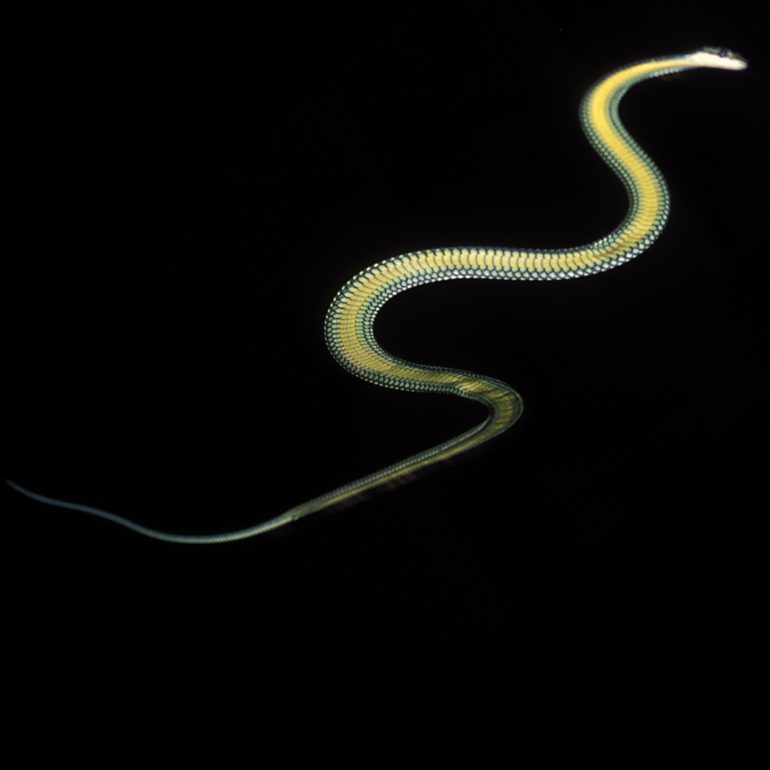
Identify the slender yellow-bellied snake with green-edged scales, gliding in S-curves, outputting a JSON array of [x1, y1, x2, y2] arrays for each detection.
[[6, 46, 748, 544]]
